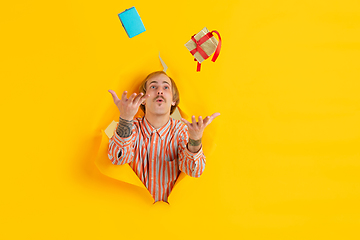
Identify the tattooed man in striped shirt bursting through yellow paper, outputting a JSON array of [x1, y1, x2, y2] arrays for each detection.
[[108, 71, 220, 202]]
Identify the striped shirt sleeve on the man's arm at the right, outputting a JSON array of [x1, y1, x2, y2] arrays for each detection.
[[178, 128, 206, 177]]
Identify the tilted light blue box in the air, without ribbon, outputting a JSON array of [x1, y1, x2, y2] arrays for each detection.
[[118, 7, 145, 38]]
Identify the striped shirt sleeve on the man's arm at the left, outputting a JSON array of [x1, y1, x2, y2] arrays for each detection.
[[108, 123, 137, 165]]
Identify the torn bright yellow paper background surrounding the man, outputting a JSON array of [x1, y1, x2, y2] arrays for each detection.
[[0, 0, 360, 239]]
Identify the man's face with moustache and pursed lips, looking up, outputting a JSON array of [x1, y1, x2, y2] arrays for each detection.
[[145, 74, 175, 115]]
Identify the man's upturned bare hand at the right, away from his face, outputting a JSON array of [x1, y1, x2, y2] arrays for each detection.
[[181, 113, 220, 141]]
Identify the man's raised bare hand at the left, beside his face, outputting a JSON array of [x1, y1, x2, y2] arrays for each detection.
[[109, 90, 150, 121]]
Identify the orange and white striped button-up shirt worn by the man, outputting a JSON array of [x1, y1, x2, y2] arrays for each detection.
[[108, 117, 205, 202]]
